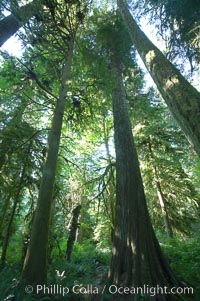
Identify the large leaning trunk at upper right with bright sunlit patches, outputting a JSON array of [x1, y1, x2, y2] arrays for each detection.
[[117, 0, 200, 156]]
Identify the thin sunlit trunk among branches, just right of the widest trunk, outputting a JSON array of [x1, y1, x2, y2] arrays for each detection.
[[148, 139, 173, 238]]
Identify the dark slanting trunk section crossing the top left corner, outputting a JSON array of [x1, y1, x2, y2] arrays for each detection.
[[0, 0, 41, 47]]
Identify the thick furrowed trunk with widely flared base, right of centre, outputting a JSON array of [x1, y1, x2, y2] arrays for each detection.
[[110, 49, 180, 301]]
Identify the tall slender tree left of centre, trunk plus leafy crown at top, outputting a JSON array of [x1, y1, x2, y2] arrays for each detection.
[[22, 3, 88, 284]]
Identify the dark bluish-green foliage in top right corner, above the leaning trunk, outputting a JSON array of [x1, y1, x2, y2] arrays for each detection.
[[143, 0, 200, 66]]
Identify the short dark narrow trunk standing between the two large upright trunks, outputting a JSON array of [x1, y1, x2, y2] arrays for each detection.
[[66, 205, 81, 261]]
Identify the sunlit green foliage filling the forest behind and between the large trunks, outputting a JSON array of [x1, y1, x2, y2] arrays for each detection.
[[0, 0, 200, 301]]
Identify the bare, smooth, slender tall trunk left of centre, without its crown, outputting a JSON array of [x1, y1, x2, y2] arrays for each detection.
[[22, 41, 74, 284]]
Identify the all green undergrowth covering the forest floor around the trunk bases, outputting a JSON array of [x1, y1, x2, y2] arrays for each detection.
[[0, 236, 200, 301]]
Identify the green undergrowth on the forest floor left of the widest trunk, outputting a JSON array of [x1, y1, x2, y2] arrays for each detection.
[[0, 240, 111, 301]]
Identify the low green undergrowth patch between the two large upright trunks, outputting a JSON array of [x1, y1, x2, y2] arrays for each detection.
[[48, 239, 111, 300]]
